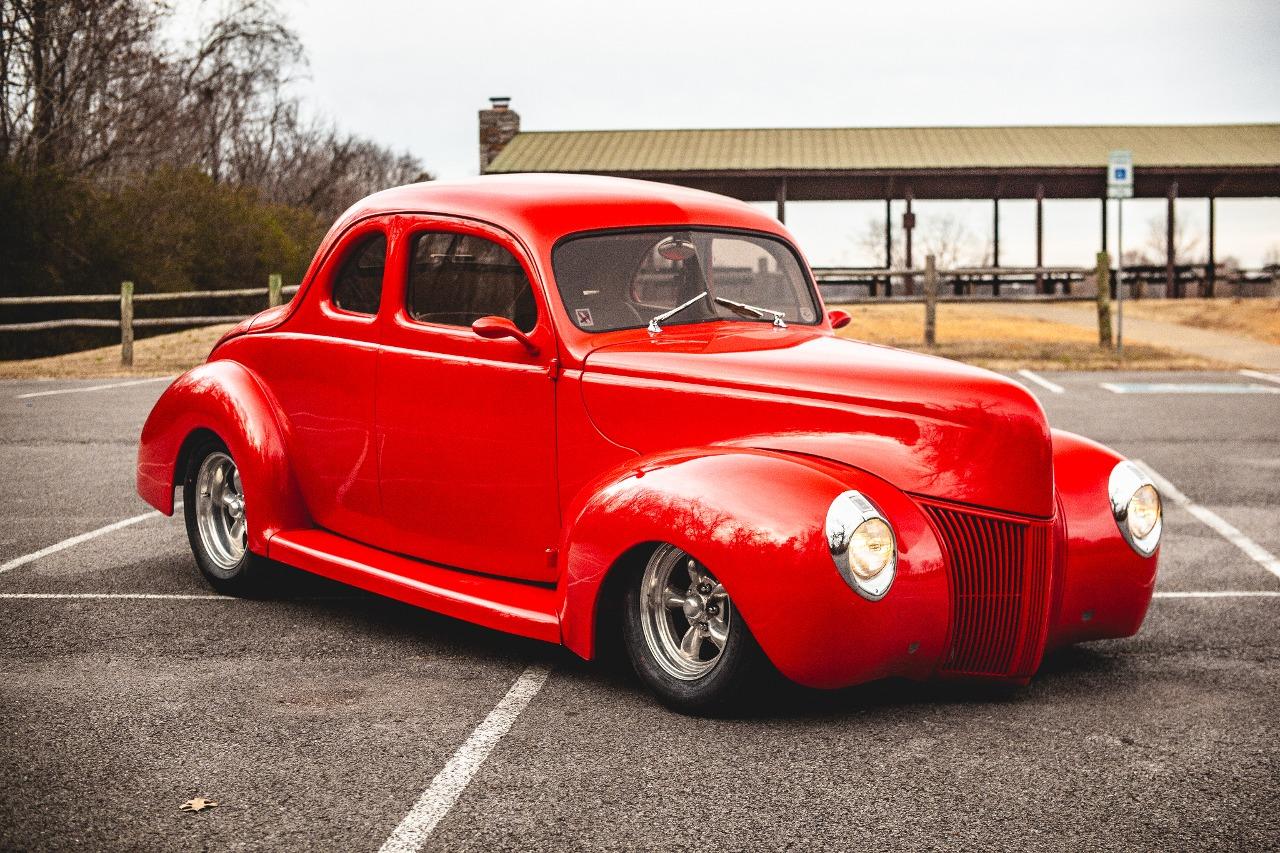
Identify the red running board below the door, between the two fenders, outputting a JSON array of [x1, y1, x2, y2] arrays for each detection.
[[266, 529, 561, 643]]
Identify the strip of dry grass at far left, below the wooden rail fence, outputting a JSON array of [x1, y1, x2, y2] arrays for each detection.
[[0, 325, 230, 379]]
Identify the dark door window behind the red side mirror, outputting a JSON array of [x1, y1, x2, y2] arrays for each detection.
[[406, 232, 538, 332]]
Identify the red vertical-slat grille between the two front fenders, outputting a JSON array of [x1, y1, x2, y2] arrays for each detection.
[[922, 503, 1052, 678]]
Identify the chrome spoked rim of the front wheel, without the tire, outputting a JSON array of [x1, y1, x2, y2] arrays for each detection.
[[640, 544, 733, 681]]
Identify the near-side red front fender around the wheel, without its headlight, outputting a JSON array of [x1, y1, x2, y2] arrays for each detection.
[[561, 447, 948, 686]]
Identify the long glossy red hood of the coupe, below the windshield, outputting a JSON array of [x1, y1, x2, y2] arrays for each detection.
[[582, 324, 1053, 517]]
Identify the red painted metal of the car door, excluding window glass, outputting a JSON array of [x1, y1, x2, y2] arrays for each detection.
[[366, 216, 561, 583]]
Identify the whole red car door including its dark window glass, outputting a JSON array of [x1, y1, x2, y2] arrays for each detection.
[[376, 218, 559, 581]]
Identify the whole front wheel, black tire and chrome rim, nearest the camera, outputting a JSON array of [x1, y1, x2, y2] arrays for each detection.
[[622, 544, 767, 715]]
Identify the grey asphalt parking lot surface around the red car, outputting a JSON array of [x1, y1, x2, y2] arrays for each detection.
[[0, 373, 1280, 852]]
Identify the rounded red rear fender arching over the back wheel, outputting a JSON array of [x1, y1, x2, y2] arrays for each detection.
[[137, 361, 310, 553]]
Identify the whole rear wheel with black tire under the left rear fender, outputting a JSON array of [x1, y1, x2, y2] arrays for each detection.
[[182, 438, 266, 596]]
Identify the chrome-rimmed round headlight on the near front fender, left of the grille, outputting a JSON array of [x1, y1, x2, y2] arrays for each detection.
[[827, 492, 897, 601]]
